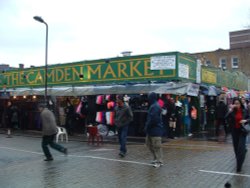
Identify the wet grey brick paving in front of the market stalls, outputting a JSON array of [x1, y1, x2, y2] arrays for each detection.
[[0, 130, 250, 188]]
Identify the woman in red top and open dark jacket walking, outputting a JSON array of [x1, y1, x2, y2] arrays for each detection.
[[226, 98, 250, 172]]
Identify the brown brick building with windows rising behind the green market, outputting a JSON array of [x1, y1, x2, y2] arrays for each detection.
[[192, 29, 250, 77]]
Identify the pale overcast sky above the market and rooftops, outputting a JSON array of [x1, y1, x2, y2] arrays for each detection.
[[0, 0, 250, 67]]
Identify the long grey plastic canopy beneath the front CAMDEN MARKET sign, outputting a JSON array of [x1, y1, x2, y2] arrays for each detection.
[[6, 82, 199, 96]]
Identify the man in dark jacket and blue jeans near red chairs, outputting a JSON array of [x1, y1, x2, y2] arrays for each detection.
[[115, 95, 133, 157]]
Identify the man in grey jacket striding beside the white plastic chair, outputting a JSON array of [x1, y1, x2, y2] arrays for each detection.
[[38, 104, 68, 161]]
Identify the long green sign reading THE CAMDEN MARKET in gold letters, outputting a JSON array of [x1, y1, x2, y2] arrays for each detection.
[[0, 52, 196, 88]]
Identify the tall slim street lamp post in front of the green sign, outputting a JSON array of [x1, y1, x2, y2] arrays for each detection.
[[33, 16, 49, 105]]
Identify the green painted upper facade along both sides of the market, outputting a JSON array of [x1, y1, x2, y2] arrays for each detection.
[[0, 52, 247, 90]]
